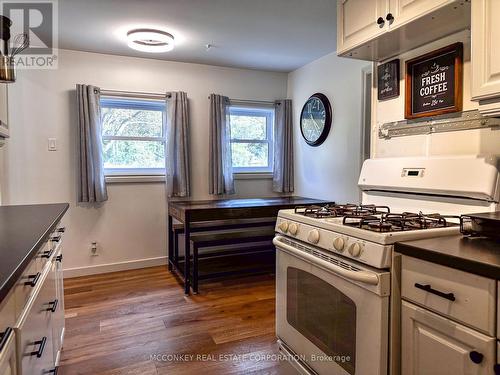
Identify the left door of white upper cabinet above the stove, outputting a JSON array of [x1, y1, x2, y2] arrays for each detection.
[[337, 0, 389, 52]]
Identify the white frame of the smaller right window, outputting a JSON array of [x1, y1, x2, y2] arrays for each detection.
[[229, 105, 275, 175]]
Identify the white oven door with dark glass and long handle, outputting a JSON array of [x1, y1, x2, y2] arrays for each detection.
[[273, 235, 390, 375]]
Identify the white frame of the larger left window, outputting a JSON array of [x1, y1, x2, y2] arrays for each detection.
[[100, 96, 166, 182]]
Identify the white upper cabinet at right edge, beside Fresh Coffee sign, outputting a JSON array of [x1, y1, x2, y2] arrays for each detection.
[[471, 0, 500, 106]]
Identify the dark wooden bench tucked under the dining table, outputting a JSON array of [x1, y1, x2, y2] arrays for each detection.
[[178, 226, 274, 294]]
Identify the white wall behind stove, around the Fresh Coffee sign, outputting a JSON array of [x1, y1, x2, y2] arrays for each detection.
[[371, 30, 500, 157]]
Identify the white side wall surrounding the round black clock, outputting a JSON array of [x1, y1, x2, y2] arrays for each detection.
[[288, 52, 370, 202]]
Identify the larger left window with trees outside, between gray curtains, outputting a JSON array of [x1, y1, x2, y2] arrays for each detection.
[[101, 97, 165, 175]]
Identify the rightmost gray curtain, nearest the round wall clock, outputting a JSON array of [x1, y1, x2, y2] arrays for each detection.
[[273, 99, 294, 193]]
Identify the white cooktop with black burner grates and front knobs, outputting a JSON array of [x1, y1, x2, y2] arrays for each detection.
[[276, 203, 460, 268]]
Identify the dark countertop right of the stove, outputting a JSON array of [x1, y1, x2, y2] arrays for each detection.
[[394, 235, 500, 279]]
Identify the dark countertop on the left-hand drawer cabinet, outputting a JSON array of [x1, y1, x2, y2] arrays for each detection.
[[0, 203, 69, 303]]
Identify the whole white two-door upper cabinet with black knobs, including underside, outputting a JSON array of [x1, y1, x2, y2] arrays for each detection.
[[337, 0, 470, 61]]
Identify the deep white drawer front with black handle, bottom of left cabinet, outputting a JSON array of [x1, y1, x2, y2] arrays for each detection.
[[15, 270, 54, 374]]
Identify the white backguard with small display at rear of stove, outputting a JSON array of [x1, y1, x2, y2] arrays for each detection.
[[358, 155, 500, 202]]
